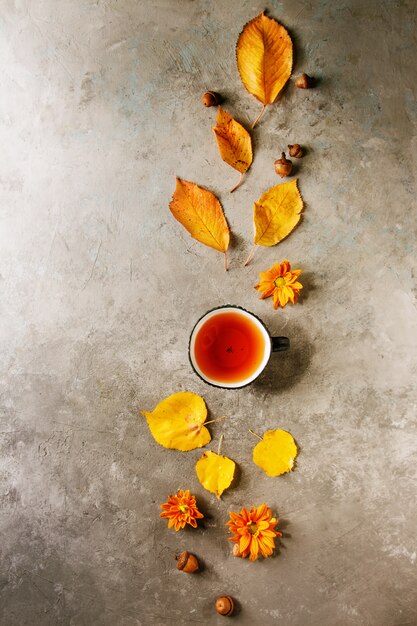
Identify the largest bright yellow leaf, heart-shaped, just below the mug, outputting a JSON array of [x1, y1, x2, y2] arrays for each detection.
[[141, 391, 211, 452]]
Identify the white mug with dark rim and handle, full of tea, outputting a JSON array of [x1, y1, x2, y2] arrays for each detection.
[[188, 304, 290, 389]]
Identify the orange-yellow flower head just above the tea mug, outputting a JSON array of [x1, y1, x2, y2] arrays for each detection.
[[255, 260, 303, 309]]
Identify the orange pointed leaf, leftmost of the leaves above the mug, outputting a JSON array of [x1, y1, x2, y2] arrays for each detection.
[[169, 178, 230, 269]]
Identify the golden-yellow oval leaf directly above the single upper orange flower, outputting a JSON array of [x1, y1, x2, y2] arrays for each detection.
[[254, 179, 303, 246]]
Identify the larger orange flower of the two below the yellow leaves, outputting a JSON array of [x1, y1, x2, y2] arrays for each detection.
[[226, 504, 282, 561]]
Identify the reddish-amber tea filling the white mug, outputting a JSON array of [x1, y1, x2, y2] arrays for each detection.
[[194, 311, 265, 383]]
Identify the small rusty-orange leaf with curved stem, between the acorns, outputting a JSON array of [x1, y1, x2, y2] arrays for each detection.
[[213, 107, 252, 191]]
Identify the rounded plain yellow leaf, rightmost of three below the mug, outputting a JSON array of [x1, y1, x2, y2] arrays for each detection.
[[253, 430, 297, 476]]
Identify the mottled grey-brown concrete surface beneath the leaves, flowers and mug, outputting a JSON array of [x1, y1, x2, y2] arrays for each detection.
[[0, 0, 417, 626]]
